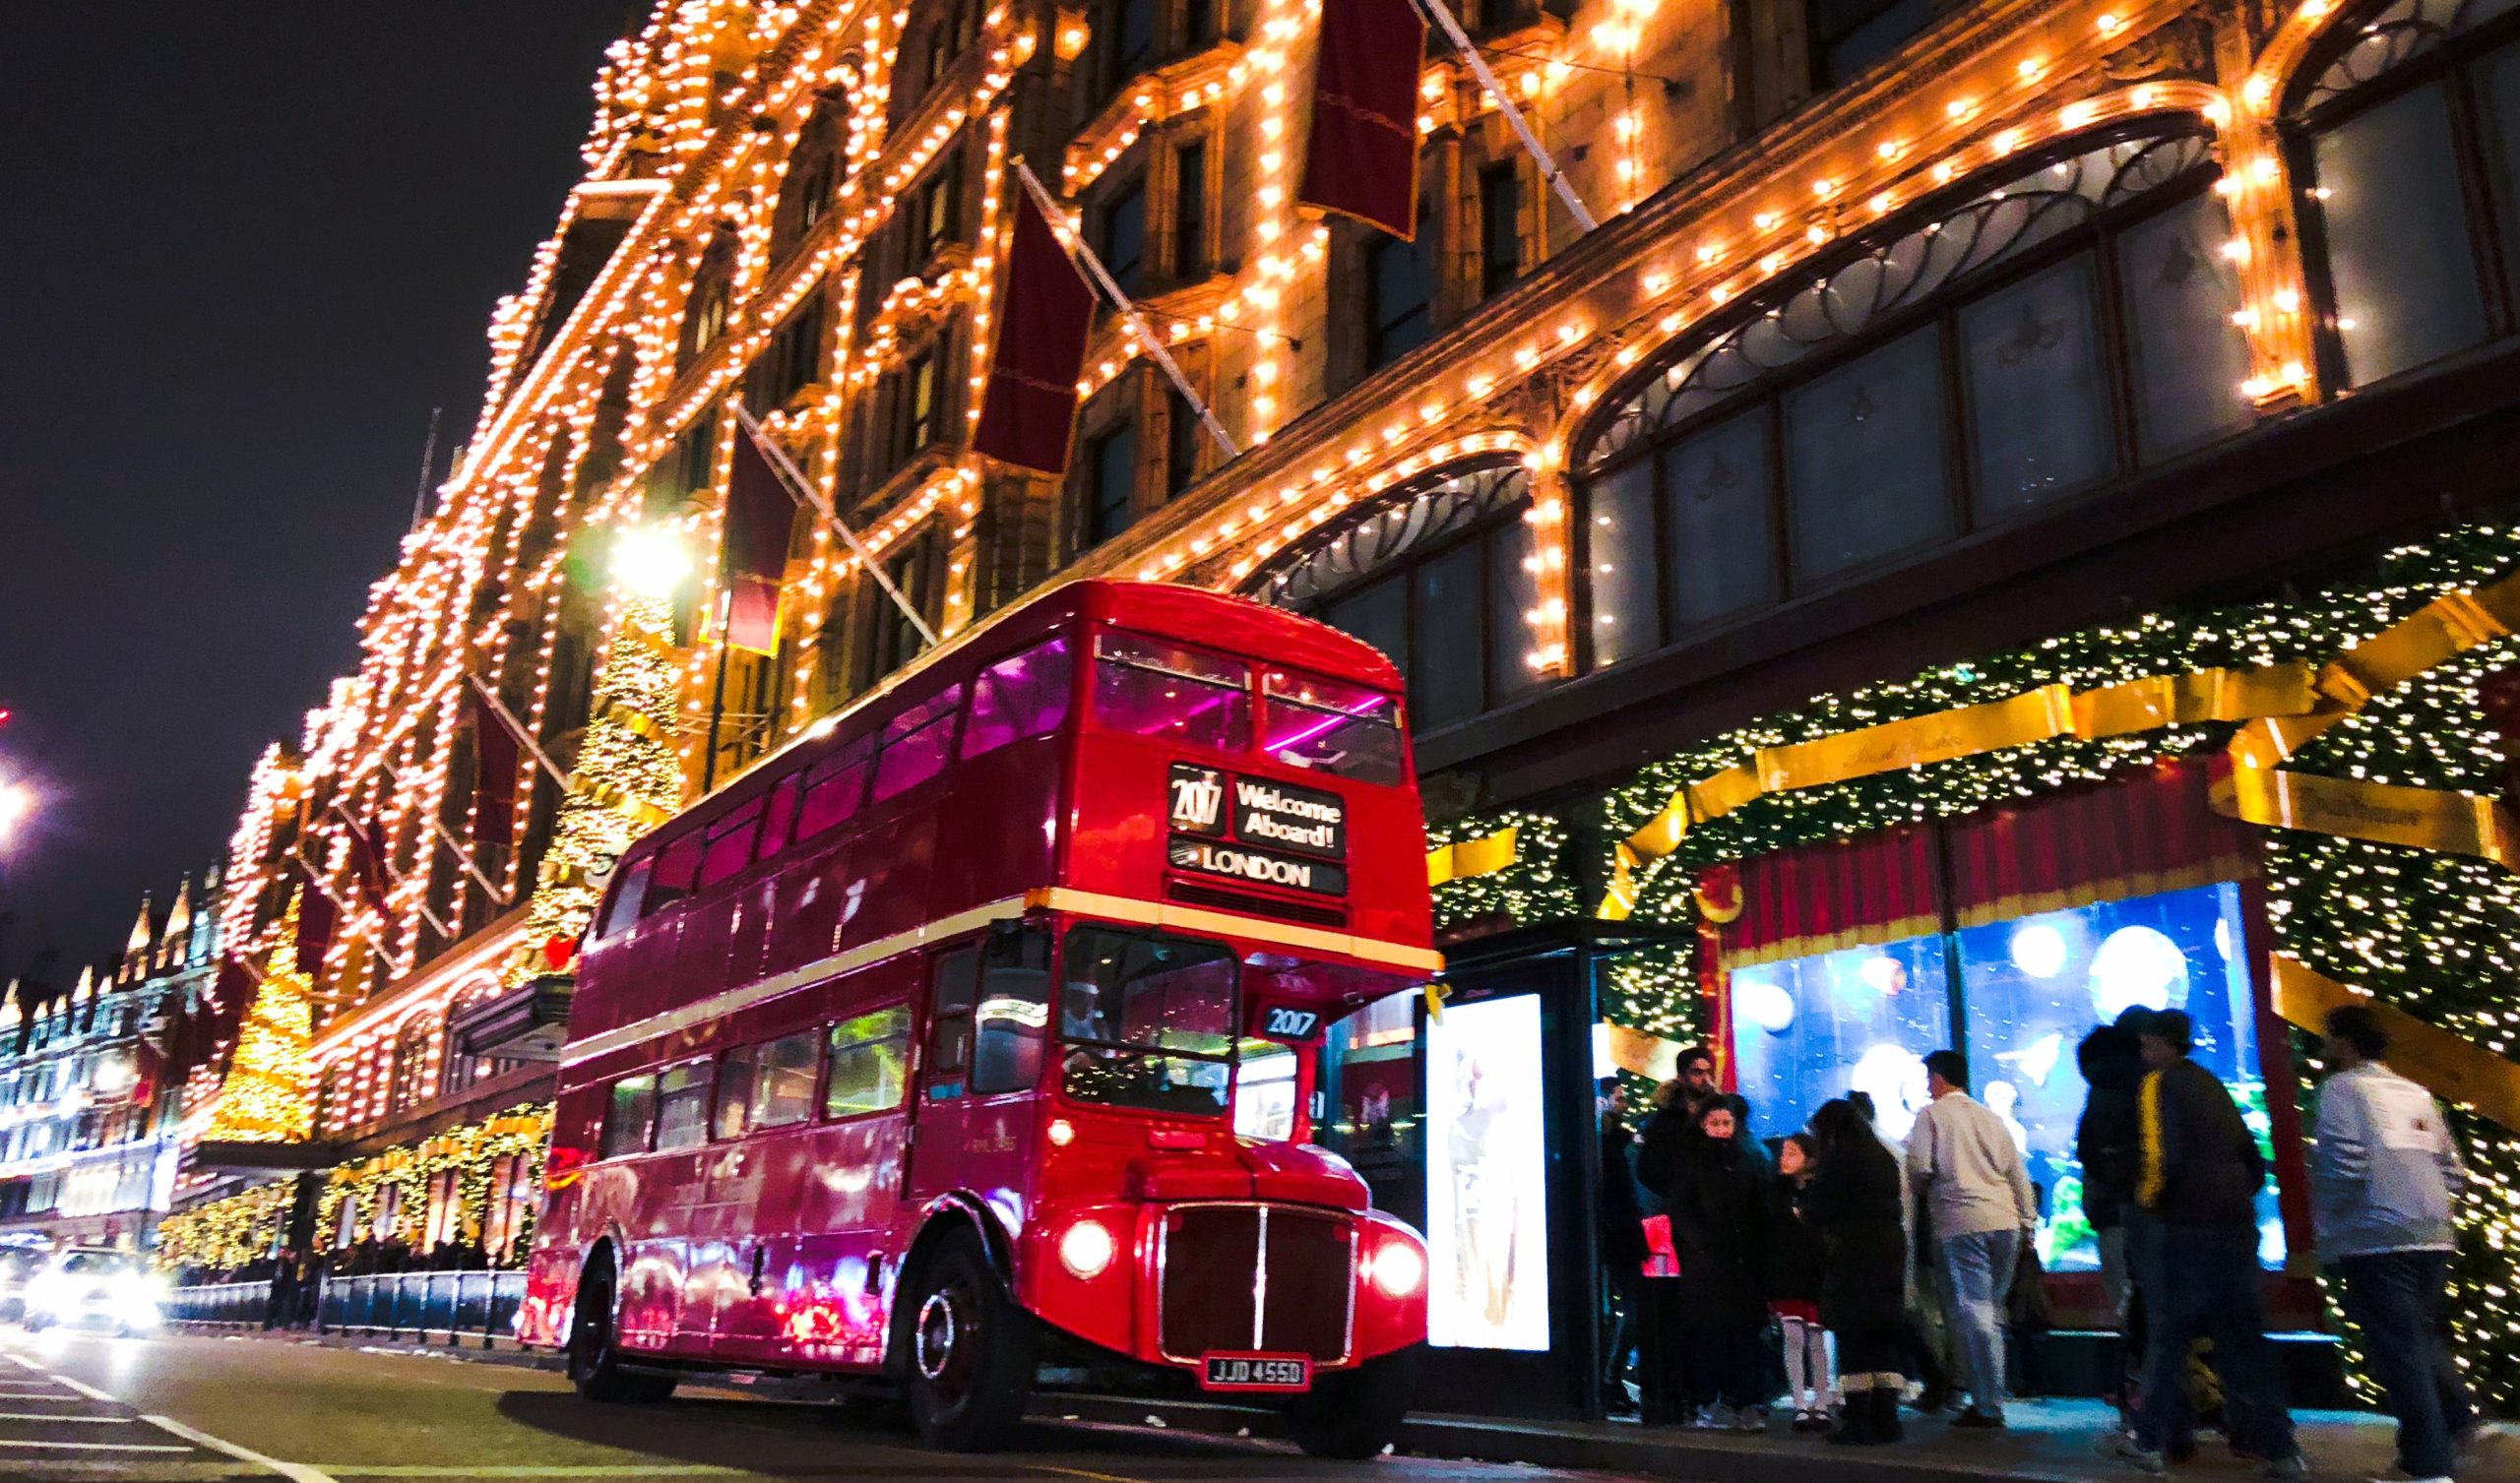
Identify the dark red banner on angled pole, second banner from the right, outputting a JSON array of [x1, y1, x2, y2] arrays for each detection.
[[971, 184, 1094, 473]]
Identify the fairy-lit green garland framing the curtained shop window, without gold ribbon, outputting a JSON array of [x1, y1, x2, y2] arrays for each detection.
[[1603, 526, 2520, 1410]]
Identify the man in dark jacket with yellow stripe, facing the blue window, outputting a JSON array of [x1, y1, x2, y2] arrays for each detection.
[[2099, 1010, 2305, 1478]]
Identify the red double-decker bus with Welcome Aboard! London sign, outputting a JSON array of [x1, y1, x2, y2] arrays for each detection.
[[519, 582, 1441, 1455]]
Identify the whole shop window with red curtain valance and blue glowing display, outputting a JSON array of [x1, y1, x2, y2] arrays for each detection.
[[1701, 763, 2299, 1271]]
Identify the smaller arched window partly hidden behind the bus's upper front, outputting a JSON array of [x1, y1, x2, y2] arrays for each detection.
[[1245, 461, 1540, 730]]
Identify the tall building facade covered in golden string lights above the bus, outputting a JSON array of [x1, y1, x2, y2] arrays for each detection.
[[186, 0, 2520, 1409]]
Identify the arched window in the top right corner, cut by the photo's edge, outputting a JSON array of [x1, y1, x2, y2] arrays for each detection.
[[2286, 0, 2520, 385]]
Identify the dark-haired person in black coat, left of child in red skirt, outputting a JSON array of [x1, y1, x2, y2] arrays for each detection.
[[1664, 1095, 1767, 1430]]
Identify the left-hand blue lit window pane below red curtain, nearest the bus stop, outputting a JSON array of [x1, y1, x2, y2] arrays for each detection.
[[1732, 934, 1955, 1143]]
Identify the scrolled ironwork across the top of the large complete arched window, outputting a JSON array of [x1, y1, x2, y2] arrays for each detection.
[[1575, 132, 2217, 473]]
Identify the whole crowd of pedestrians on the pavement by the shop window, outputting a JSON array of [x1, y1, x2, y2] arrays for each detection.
[[1601, 1005, 2489, 1483]]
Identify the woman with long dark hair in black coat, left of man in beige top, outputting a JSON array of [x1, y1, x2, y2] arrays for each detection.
[[1801, 1100, 1908, 1446]]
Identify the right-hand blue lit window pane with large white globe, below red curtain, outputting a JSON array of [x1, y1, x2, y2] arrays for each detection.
[[1953, 882, 2283, 1271]]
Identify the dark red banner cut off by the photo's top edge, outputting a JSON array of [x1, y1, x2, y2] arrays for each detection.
[[1295, 0, 1426, 242]]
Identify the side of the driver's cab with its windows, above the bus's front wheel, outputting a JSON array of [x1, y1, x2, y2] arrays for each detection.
[[902, 921, 1051, 1226]]
